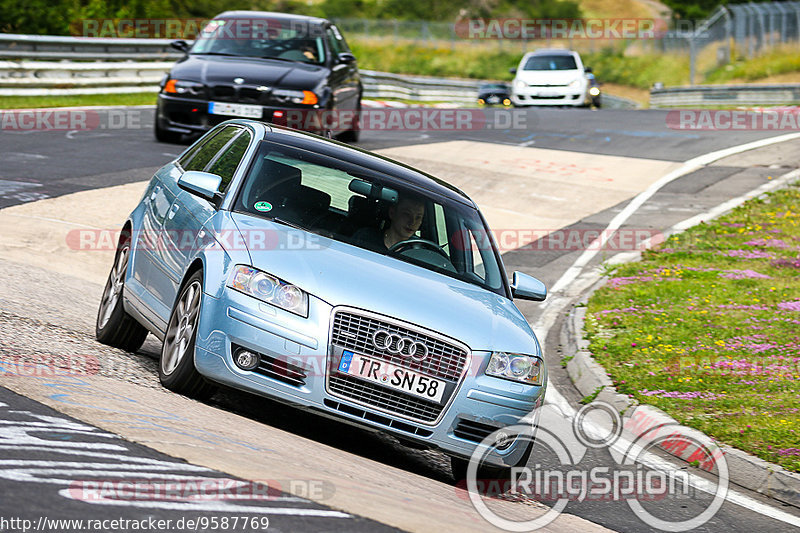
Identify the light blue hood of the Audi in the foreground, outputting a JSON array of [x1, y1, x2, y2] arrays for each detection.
[[232, 213, 540, 354]]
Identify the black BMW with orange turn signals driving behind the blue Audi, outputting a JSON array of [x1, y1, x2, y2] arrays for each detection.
[[155, 11, 363, 142]]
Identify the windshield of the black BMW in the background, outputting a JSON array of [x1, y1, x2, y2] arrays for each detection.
[[191, 19, 325, 65]]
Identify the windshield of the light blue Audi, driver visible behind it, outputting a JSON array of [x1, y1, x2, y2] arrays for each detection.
[[234, 141, 507, 296]]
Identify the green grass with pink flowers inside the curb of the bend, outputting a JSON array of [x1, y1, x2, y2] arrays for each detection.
[[586, 185, 800, 472]]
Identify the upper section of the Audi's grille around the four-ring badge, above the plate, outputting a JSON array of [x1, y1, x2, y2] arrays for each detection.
[[331, 312, 467, 381]]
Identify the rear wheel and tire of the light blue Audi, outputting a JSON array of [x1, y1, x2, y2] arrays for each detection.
[[94, 233, 147, 352]]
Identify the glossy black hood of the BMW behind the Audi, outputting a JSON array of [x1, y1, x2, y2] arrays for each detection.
[[170, 55, 328, 90]]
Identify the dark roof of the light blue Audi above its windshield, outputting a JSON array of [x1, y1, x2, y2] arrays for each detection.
[[234, 119, 477, 209]]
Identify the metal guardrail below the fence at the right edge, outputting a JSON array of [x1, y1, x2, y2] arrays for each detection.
[[650, 84, 800, 107]]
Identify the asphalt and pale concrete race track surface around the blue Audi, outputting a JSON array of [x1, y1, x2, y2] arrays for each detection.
[[0, 108, 800, 533]]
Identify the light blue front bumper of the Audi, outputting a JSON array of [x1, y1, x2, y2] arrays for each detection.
[[195, 289, 545, 465]]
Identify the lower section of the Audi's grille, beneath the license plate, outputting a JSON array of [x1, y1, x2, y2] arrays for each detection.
[[328, 374, 444, 422]]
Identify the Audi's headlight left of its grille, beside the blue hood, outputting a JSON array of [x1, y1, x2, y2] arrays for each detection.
[[228, 265, 308, 317]]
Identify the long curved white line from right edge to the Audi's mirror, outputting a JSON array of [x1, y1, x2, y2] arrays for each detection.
[[540, 129, 800, 296]]
